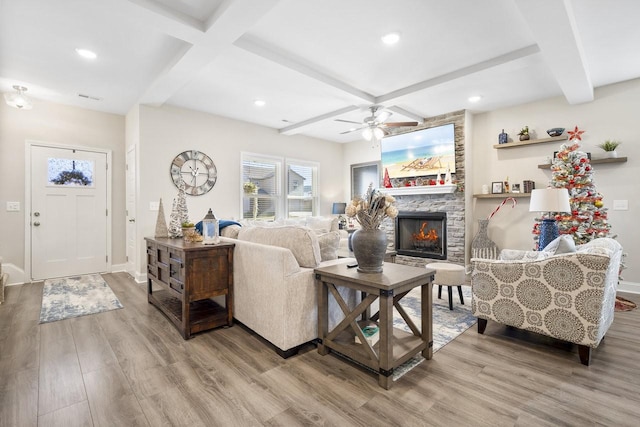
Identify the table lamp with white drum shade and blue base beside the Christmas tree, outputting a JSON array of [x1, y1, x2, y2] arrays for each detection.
[[529, 188, 571, 251]]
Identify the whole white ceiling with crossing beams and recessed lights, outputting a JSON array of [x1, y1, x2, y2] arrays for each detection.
[[0, 0, 640, 142]]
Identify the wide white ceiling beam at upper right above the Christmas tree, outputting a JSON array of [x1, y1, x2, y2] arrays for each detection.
[[516, 0, 594, 104]]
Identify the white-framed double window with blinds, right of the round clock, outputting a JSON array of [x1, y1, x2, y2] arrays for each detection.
[[241, 153, 318, 221]]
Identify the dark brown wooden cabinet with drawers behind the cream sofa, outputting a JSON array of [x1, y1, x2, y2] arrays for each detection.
[[145, 238, 235, 339]]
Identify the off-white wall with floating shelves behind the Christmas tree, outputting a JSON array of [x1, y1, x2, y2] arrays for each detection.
[[467, 79, 640, 283]]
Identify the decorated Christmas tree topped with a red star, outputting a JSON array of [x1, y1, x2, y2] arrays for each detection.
[[533, 126, 611, 247]]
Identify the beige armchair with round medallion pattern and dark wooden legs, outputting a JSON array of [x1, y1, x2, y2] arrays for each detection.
[[471, 236, 622, 365]]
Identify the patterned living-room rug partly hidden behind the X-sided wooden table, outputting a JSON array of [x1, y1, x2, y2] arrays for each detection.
[[393, 286, 478, 381]]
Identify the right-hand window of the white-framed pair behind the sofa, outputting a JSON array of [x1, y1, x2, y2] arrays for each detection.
[[287, 159, 318, 218]]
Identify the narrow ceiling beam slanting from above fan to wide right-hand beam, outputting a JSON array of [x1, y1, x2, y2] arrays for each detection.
[[376, 45, 540, 103]]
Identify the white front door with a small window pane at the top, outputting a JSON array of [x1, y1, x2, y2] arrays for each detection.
[[30, 145, 108, 280]]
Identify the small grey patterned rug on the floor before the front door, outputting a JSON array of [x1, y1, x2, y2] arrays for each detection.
[[40, 274, 122, 323]]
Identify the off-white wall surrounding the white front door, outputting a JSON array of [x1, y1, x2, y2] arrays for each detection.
[[0, 100, 125, 283]]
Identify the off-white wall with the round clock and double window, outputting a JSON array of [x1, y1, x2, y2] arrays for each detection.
[[132, 106, 348, 278]]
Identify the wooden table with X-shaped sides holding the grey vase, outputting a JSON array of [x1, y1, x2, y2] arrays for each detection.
[[315, 263, 435, 389]]
